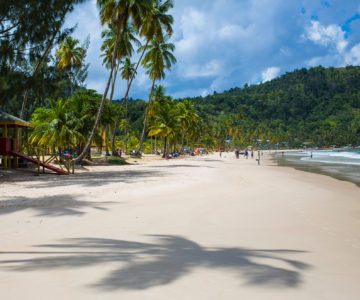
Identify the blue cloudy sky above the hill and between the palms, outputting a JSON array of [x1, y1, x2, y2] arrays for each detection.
[[65, 0, 360, 99]]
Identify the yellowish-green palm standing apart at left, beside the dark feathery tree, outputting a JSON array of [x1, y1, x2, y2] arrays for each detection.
[[56, 36, 86, 95]]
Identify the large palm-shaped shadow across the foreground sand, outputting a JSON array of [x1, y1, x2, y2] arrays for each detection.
[[0, 235, 309, 291]]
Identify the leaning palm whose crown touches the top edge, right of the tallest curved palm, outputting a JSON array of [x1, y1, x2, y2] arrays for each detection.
[[122, 0, 174, 105]]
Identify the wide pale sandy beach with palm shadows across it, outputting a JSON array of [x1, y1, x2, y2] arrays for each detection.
[[0, 153, 360, 300]]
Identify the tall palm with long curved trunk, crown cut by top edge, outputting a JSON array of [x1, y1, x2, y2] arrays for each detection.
[[75, 0, 151, 162]]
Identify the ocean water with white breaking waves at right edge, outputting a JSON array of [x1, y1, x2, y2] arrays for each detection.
[[274, 149, 360, 186]]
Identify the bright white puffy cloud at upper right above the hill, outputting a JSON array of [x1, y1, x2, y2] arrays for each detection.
[[305, 21, 348, 53]]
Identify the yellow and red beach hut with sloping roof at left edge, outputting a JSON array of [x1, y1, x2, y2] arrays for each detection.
[[0, 110, 34, 169]]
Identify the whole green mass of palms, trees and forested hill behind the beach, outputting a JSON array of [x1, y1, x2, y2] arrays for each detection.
[[0, 0, 360, 162]]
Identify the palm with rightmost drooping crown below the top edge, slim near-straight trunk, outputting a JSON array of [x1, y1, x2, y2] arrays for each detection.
[[137, 37, 176, 154]]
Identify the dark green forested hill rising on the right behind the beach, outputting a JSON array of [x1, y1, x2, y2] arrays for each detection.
[[188, 66, 360, 146]]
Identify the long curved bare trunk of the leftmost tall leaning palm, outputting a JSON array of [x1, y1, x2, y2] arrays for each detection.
[[75, 25, 120, 163]]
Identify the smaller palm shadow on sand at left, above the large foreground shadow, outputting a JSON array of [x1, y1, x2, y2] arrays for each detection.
[[0, 195, 115, 217]]
